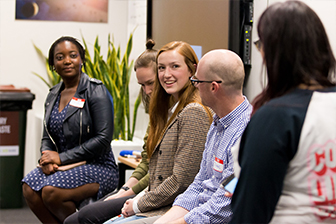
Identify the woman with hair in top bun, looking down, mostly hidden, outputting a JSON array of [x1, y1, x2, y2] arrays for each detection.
[[64, 40, 157, 224]]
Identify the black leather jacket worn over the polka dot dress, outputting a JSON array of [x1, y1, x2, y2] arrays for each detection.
[[41, 73, 114, 164]]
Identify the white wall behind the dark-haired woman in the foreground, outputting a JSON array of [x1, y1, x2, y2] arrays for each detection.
[[245, 0, 336, 102]]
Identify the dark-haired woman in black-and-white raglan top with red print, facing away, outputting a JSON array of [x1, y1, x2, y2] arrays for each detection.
[[231, 1, 336, 223]]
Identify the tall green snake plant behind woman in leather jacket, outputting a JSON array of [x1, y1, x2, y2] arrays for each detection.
[[33, 33, 141, 140]]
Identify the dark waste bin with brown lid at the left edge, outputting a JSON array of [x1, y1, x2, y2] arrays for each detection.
[[0, 85, 35, 208]]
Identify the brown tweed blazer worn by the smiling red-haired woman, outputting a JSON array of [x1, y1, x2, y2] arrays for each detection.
[[137, 103, 212, 217]]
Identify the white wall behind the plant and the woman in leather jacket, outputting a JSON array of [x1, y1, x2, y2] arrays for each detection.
[[0, 0, 148, 174]]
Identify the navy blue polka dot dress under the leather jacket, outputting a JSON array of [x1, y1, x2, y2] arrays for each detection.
[[22, 95, 119, 199]]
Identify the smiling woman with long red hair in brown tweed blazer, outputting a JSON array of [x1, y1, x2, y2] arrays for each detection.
[[105, 41, 212, 223]]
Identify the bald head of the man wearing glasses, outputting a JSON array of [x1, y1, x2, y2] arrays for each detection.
[[198, 49, 245, 90]]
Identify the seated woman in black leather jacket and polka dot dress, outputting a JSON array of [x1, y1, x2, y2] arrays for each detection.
[[22, 36, 118, 223]]
